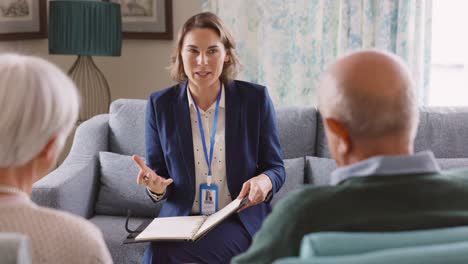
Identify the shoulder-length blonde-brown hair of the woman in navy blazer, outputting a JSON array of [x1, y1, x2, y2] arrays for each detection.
[[169, 12, 241, 83]]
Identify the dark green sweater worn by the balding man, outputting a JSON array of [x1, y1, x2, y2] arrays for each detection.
[[232, 170, 468, 264]]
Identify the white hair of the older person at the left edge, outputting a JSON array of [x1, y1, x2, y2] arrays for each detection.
[[0, 54, 80, 167]]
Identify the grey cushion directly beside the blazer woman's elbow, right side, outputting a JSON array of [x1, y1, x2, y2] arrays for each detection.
[[271, 158, 305, 205]]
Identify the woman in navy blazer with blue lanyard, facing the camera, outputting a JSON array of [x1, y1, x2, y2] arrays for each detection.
[[134, 12, 285, 263]]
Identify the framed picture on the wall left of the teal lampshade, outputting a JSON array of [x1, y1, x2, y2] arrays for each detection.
[[0, 0, 47, 40]]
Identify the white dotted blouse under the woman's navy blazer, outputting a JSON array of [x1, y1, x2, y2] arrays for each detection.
[[187, 86, 233, 214]]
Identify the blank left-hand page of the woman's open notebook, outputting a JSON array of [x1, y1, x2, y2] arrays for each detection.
[[135, 215, 206, 241]]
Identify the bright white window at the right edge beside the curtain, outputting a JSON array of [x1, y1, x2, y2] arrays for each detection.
[[428, 0, 468, 106]]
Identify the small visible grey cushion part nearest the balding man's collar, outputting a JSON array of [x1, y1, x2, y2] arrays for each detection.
[[305, 156, 336, 186]]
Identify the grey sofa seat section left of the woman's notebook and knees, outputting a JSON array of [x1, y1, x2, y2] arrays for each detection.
[[89, 215, 151, 264]]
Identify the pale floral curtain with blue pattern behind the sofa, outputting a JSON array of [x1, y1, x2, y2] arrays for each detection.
[[201, 0, 432, 106]]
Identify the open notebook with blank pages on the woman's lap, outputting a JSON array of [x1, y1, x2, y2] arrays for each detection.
[[134, 197, 247, 242]]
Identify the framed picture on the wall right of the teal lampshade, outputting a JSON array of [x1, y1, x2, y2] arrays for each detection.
[[110, 0, 172, 39]]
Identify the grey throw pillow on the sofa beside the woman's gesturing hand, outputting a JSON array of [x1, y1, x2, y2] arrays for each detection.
[[95, 152, 162, 217]]
